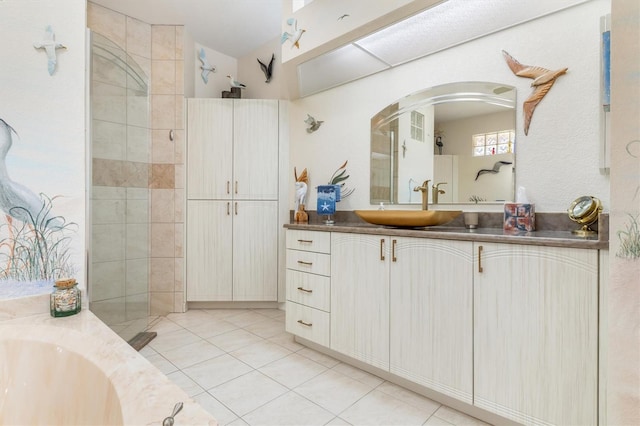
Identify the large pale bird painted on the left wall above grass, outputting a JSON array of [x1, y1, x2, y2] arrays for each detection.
[[0, 118, 63, 229]]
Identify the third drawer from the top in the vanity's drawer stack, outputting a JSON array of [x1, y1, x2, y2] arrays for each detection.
[[287, 269, 331, 312]]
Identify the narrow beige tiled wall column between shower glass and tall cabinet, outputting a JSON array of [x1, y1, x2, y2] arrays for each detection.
[[149, 25, 185, 315]]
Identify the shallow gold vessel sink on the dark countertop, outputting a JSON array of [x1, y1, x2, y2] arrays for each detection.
[[355, 210, 462, 228]]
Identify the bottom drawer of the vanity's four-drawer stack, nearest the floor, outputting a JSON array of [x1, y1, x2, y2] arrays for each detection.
[[286, 302, 329, 347]]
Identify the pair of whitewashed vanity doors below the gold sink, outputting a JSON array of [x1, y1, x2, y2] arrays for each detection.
[[331, 233, 473, 396]]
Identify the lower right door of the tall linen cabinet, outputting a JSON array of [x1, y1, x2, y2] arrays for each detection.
[[233, 201, 278, 301]]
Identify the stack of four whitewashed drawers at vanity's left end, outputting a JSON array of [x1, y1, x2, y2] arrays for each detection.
[[285, 230, 331, 346]]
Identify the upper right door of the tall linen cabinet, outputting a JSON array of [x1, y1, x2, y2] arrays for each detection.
[[233, 99, 279, 200]]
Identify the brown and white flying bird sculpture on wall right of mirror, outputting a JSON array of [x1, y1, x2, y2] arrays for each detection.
[[502, 50, 568, 135]]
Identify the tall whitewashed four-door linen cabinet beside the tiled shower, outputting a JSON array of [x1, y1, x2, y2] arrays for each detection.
[[186, 98, 286, 302]]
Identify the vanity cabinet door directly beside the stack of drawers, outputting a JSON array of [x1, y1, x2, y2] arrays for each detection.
[[330, 232, 389, 370]]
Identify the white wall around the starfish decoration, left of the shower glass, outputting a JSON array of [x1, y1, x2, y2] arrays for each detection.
[[0, 0, 86, 287]]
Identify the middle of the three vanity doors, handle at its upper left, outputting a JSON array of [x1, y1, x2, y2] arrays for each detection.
[[390, 237, 473, 404]]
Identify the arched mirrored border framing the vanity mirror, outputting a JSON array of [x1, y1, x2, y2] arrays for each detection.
[[369, 81, 517, 205]]
